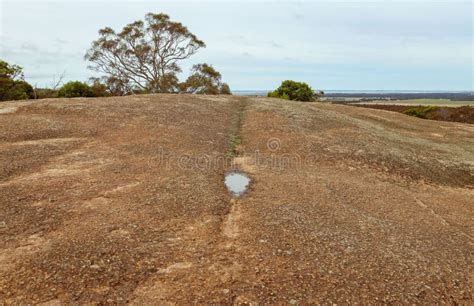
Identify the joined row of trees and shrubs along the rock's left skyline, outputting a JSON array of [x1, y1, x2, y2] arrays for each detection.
[[0, 13, 231, 101]]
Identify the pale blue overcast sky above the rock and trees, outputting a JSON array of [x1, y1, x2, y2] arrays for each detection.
[[0, 0, 473, 90]]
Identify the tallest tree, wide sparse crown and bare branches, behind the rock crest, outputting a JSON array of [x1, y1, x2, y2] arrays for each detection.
[[85, 13, 206, 93]]
